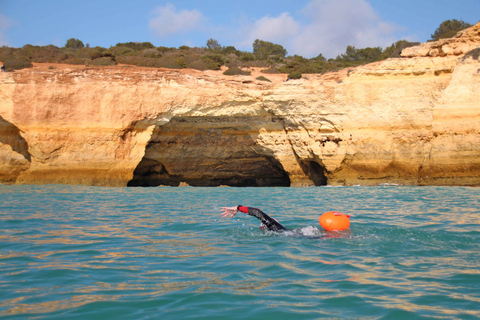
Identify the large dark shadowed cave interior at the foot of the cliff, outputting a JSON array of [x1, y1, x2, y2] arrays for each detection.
[[128, 116, 290, 187]]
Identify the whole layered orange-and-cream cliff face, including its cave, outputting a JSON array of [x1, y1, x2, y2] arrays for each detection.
[[0, 24, 480, 186]]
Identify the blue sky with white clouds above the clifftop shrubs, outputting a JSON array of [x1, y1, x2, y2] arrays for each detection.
[[0, 0, 480, 58]]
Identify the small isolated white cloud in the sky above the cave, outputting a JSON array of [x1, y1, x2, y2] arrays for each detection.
[[148, 4, 205, 38]]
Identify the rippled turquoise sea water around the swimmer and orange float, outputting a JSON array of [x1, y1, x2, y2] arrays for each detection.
[[0, 186, 480, 320]]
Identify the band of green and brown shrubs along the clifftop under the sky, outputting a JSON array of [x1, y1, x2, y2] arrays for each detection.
[[0, 19, 471, 77]]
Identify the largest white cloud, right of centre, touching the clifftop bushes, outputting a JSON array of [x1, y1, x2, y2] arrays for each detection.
[[234, 0, 399, 58]]
